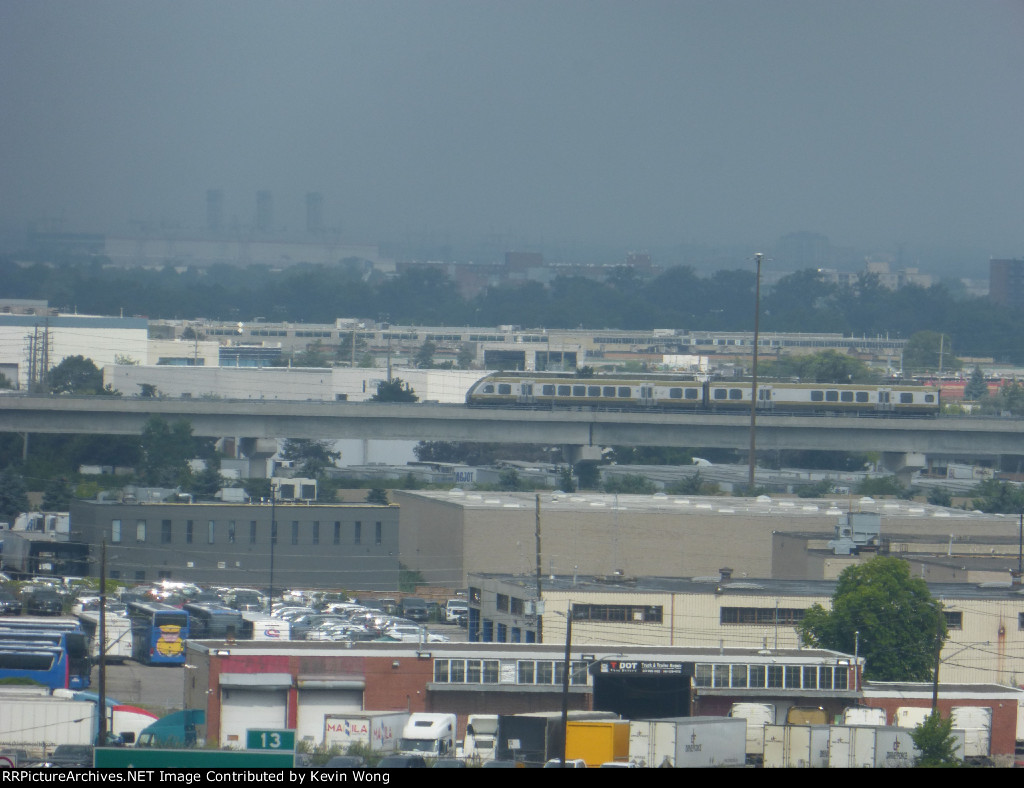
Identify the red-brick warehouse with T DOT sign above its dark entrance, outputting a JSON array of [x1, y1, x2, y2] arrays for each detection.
[[184, 641, 864, 747]]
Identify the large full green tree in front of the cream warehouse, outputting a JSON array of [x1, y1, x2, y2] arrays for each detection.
[[799, 556, 946, 682]]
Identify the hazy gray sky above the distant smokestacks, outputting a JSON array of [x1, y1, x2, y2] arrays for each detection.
[[0, 0, 1024, 264]]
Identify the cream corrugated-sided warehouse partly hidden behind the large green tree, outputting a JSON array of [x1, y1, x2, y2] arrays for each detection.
[[469, 574, 1024, 687]]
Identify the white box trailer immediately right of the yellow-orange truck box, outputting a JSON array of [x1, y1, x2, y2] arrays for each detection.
[[630, 716, 746, 769]]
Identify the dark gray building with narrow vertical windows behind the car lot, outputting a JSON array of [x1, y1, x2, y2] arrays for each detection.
[[71, 500, 399, 590]]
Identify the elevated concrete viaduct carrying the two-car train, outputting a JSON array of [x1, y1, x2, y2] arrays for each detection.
[[0, 395, 1024, 470]]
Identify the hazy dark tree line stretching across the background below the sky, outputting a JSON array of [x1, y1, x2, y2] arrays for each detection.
[[0, 257, 1024, 368]]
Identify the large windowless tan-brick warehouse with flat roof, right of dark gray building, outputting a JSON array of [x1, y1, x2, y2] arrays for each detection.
[[392, 488, 1019, 588]]
